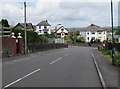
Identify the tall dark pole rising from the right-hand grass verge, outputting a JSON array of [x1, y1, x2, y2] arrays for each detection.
[[111, 0, 115, 65]]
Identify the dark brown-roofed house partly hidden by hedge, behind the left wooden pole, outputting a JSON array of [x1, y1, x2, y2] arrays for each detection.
[[14, 23, 35, 31]]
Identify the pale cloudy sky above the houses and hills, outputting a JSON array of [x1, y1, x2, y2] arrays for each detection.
[[0, 0, 118, 28]]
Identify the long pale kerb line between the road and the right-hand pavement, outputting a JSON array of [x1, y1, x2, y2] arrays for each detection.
[[91, 51, 106, 89]]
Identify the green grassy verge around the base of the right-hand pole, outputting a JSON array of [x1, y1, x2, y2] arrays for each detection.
[[99, 49, 120, 67]]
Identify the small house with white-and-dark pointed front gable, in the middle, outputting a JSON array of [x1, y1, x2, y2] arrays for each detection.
[[55, 26, 69, 38]]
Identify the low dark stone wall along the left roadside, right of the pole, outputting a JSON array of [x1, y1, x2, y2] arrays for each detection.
[[28, 43, 68, 52]]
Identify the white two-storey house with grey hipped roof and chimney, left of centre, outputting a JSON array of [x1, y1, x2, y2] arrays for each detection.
[[36, 20, 51, 35]]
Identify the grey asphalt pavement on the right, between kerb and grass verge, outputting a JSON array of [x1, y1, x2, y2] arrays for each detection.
[[92, 49, 119, 87]]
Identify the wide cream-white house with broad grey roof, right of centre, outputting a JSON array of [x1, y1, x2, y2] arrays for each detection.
[[80, 24, 107, 42]]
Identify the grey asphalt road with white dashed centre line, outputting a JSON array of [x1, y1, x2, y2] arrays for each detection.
[[3, 47, 101, 87]]
